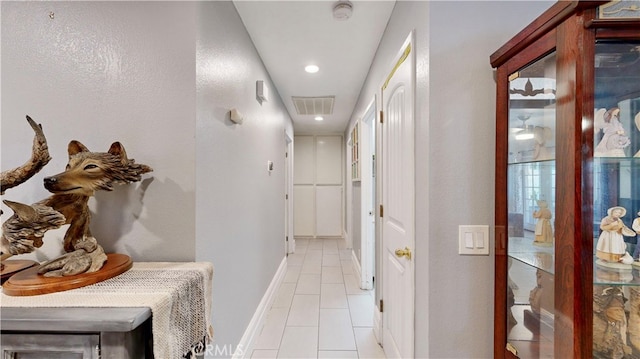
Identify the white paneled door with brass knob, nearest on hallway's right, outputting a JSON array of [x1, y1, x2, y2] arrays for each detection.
[[381, 35, 415, 358]]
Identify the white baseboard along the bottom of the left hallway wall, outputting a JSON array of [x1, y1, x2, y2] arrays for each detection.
[[232, 257, 287, 359]]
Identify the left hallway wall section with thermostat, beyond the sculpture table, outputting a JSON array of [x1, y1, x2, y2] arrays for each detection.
[[195, 1, 293, 354]]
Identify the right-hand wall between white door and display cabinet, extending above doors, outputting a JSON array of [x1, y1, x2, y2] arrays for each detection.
[[352, 1, 551, 358]]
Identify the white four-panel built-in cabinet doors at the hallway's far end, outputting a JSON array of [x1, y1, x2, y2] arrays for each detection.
[[293, 135, 344, 237]]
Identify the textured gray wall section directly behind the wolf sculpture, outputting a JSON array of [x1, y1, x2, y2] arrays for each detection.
[[1, 2, 196, 261]]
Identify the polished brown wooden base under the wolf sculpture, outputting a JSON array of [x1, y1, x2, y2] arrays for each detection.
[[2, 253, 133, 296]]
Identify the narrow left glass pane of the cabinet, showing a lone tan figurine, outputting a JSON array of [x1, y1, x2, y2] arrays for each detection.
[[507, 53, 556, 358]]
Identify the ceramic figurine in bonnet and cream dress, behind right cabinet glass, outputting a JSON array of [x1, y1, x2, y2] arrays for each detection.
[[596, 207, 635, 265]]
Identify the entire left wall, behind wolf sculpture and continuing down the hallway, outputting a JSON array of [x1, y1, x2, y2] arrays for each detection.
[[0, 1, 293, 356]]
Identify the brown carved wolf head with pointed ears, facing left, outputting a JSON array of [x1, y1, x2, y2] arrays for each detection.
[[44, 140, 153, 196]]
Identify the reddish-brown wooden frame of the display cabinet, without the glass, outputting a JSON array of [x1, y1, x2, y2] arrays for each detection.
[[490, 1, 640, 358]]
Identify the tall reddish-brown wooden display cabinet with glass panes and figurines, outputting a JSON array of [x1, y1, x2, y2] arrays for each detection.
[[490, 0, 640, 359]]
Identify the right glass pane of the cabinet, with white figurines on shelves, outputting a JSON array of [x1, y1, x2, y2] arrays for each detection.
[[588, 41, 640, 358]]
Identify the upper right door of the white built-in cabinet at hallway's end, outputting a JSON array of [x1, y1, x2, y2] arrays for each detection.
[[316, 136, 342, 185]]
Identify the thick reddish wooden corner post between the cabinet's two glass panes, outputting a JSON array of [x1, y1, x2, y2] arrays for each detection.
[[555, 10, 595, 358]]
